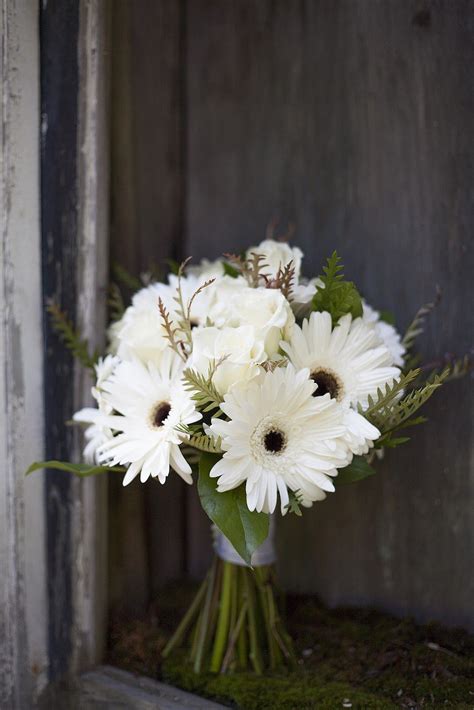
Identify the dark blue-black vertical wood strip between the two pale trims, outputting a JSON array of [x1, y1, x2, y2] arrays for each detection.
[[40, 2, 79, 678]]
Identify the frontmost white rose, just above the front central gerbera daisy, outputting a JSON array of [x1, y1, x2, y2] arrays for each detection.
[[189, 326, 267, 394]]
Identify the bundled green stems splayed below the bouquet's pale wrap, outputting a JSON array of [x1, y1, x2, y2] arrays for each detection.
[[163, 557, 296, 674]]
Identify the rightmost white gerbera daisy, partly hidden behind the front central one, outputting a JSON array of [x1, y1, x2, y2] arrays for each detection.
[[281, 312, 400, 454]]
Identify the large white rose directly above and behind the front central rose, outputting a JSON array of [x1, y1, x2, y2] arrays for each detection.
[[224, 286, 295, 357]]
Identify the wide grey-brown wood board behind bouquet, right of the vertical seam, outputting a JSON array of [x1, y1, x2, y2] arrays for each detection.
[[185, 0, 474, 627]]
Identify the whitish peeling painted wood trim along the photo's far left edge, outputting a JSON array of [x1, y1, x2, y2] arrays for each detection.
[[0, 0, 48, 709]]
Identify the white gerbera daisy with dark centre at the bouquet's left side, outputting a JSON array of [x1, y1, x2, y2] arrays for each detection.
[[98, 348, 201, 486]]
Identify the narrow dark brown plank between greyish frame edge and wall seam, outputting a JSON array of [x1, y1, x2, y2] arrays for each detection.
[[109, 0, 184, 613]]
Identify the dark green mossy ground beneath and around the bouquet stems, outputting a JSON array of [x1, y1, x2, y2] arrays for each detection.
[[109, 585, 474, 710]]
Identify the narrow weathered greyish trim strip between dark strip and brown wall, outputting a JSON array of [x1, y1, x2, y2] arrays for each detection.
[[72, 0, 109, 671]]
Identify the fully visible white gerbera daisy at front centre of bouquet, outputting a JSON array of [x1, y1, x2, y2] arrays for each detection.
[[209, 365, 352, 514]]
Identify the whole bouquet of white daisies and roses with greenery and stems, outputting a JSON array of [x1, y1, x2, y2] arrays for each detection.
[[30, 239, 466, 673]]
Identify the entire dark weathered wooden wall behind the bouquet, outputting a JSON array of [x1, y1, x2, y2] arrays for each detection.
[[112, 0, 474, 626]]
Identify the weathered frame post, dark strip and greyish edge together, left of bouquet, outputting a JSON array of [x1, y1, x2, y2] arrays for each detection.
[[41, 0, 109, 680]]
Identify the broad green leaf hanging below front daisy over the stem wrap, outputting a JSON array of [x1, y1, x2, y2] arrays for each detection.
[[198, 454, 269, 566]]
